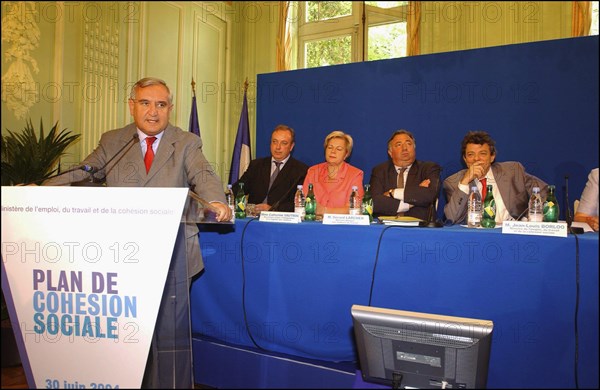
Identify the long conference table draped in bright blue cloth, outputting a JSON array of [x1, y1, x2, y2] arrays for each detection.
[[191, 219, 599, 388]]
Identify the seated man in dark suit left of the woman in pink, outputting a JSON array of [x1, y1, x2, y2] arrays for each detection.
[[232, 125, 308, 211]]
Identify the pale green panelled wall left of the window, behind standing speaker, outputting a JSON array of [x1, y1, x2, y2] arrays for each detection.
[[2, 2, 277, 182]]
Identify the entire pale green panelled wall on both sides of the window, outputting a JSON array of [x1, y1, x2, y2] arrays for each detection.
[[1, 1, 592, 181]]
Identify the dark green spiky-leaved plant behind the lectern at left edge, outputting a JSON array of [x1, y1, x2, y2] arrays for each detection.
[[0, 119, 80, 367]]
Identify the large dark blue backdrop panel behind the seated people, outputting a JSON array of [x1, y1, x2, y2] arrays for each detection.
[[256, 36, 599, 218]]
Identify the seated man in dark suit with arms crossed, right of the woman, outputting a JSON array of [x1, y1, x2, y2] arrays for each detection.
[[370, 130, 441, 221]]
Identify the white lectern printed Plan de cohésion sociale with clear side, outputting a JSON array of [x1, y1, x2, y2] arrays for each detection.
[[2, 187, 197, 388]]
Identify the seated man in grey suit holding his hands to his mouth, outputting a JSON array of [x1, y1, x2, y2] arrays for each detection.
[[444, 131, 548, 223]]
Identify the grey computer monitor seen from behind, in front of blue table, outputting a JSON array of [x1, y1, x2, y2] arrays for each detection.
[[351, 305, 494, 389]]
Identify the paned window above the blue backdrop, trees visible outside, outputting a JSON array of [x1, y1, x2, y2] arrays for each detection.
[[298, 1, 408, 68]]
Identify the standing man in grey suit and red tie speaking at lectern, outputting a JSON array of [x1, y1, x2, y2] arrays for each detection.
[[44, 78, 231, 388]]
